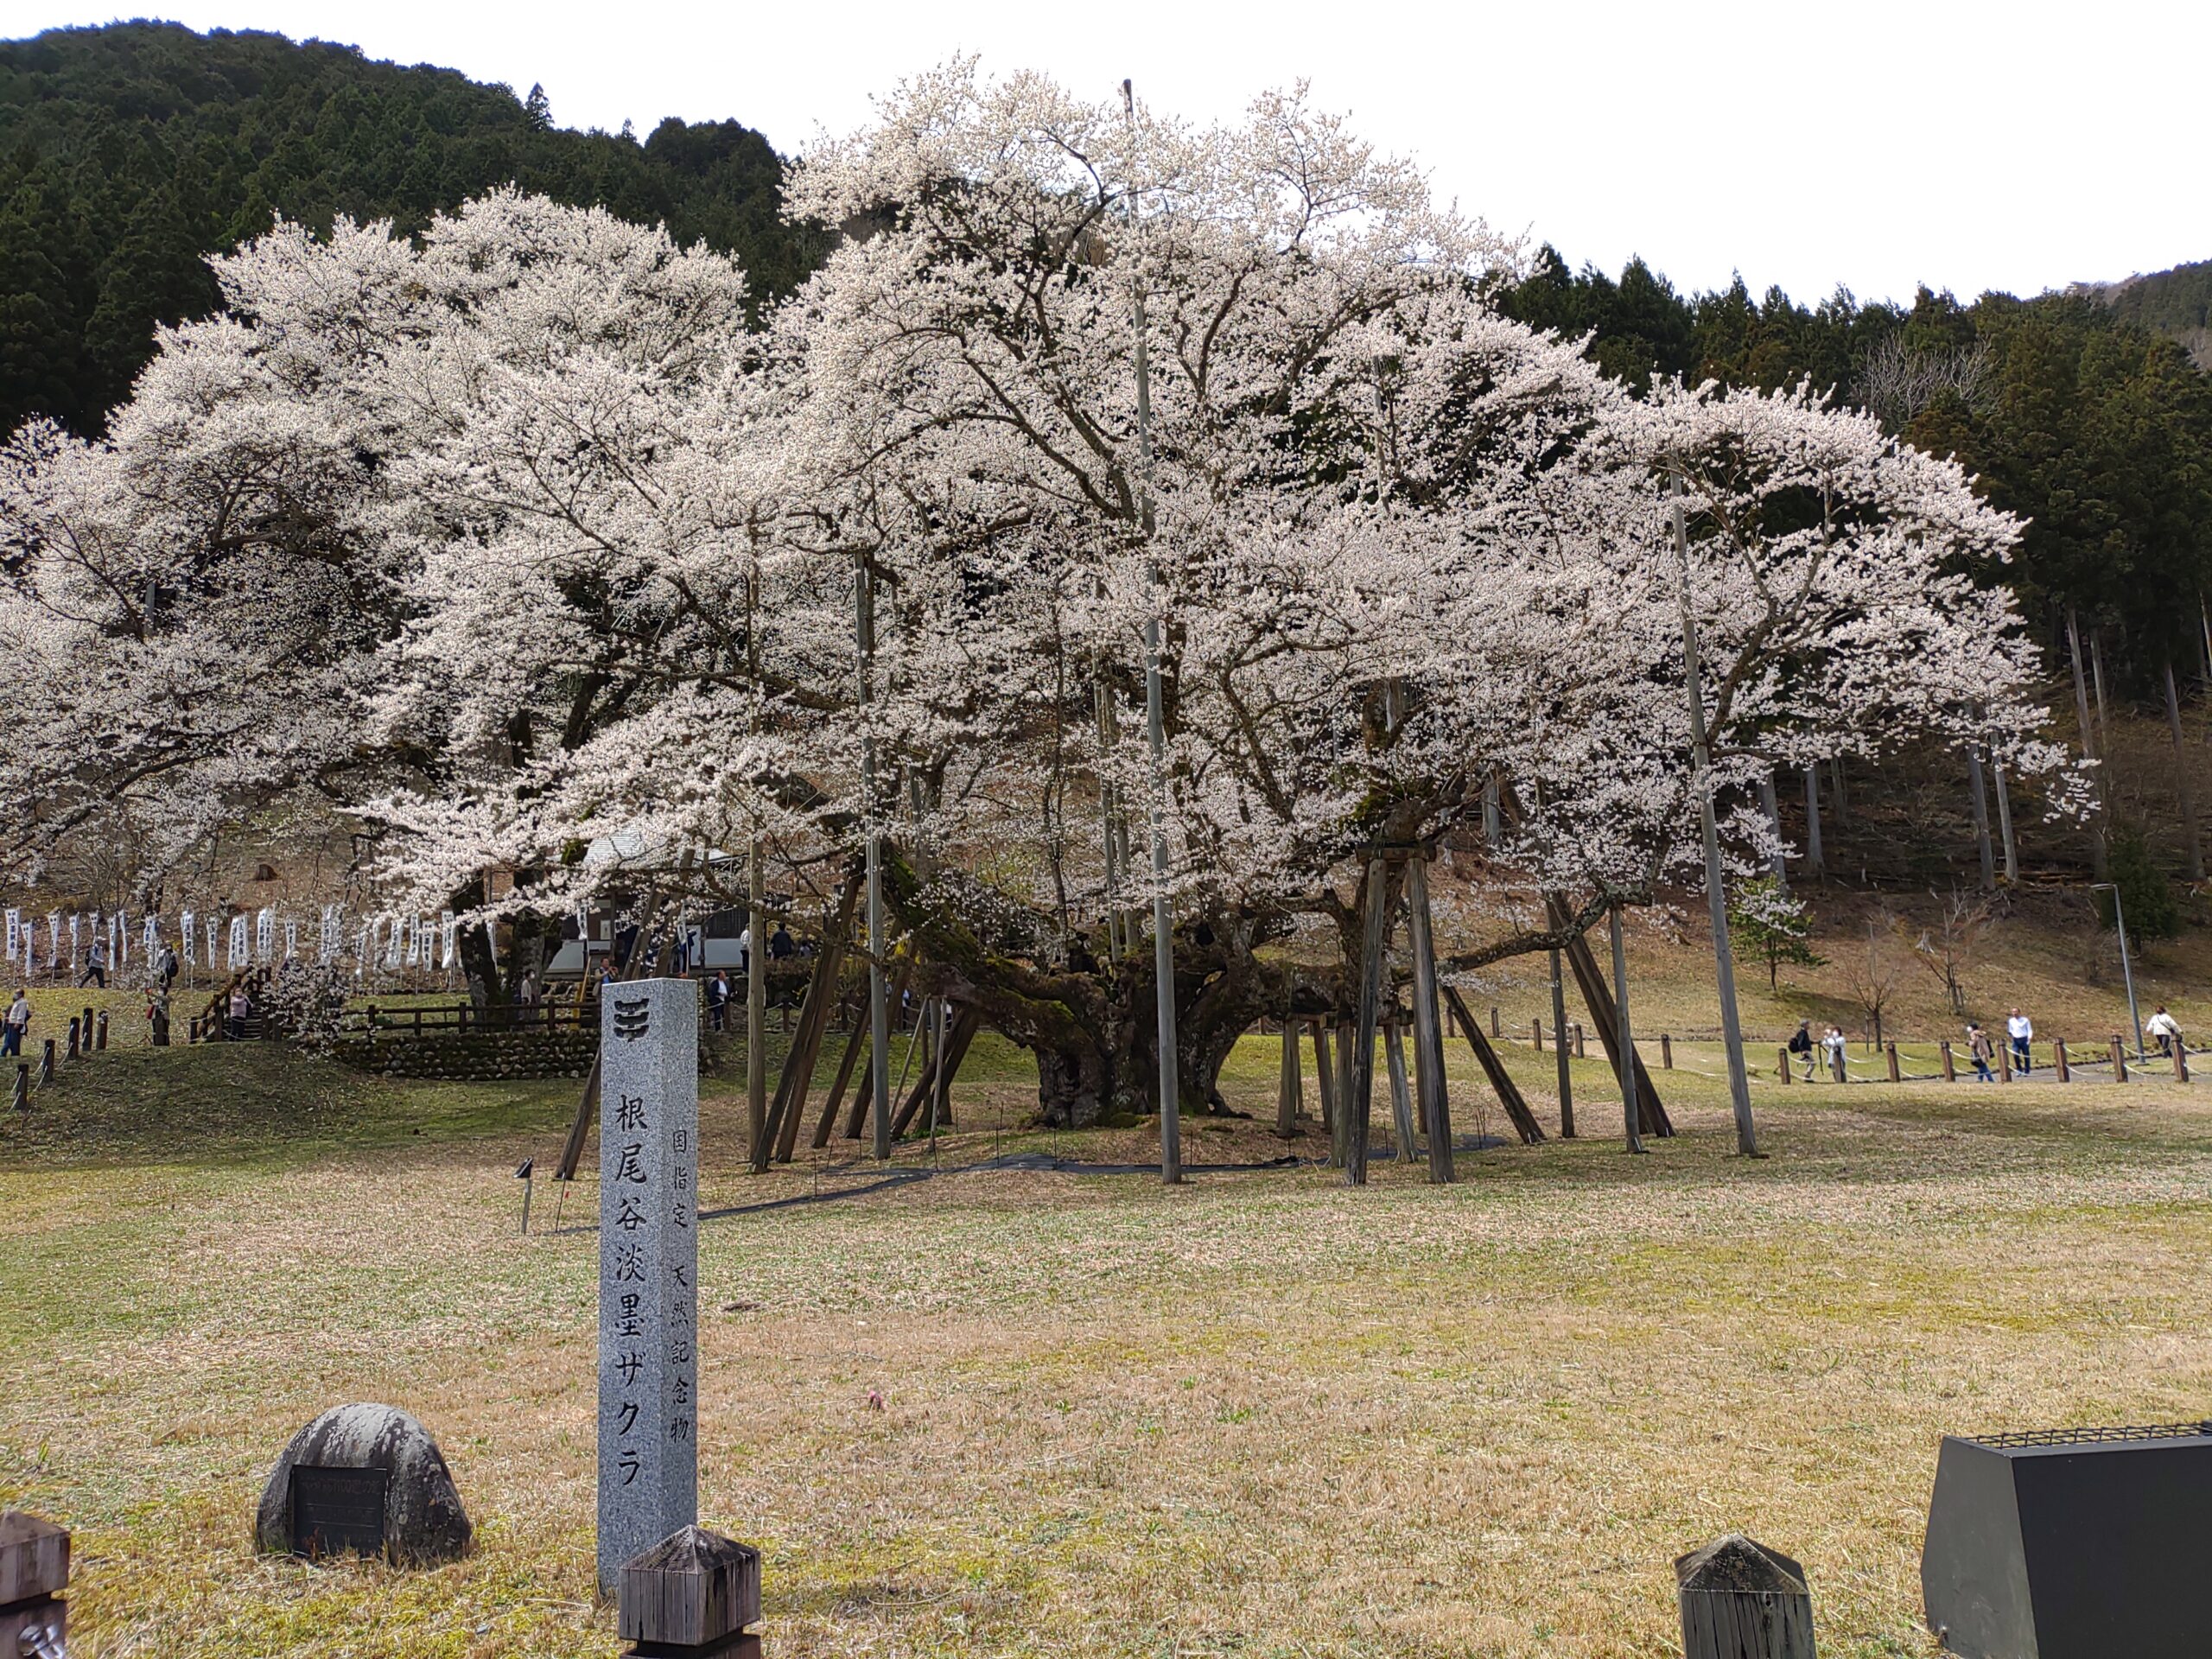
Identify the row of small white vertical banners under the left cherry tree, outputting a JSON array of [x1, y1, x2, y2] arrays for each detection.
[[7, 905, 458, 976]]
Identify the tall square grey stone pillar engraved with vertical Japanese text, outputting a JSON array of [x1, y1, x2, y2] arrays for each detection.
[[600, 980, 699, 1595]]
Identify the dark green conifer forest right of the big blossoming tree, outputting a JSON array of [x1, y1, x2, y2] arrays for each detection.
[[1504, 248, 2212, 696]]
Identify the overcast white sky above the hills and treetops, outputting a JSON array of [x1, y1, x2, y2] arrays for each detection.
[[17, 0, 2212, 299]]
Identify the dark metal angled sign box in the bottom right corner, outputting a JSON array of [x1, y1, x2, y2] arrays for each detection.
[[1920, 1422, 2212, 1659]]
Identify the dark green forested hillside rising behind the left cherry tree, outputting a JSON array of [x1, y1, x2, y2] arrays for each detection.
[[0, 22, 814, 431]]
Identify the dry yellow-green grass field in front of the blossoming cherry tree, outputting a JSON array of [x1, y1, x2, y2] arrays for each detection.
[[0, 1021, 2212, 1659]]
